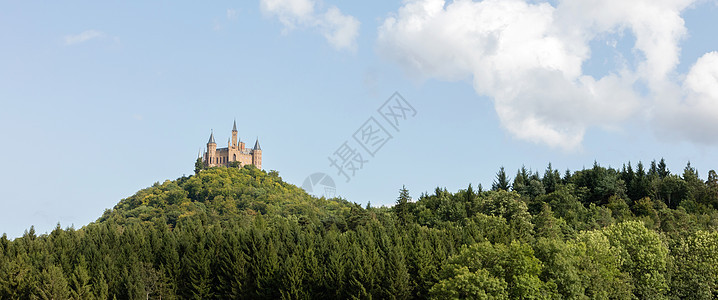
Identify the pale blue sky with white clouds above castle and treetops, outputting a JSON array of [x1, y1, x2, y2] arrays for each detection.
[[0, 0, 718, 238]]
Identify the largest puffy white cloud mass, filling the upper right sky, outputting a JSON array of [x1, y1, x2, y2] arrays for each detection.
[[377, 0, 718, 150]]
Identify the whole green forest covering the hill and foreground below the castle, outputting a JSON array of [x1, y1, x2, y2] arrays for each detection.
[[0, 159, 718, 299]]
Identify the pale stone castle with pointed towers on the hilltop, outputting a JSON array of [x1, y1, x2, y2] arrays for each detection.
[[202, 121, 262, 169]]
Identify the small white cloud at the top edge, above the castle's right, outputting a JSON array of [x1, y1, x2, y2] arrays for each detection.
[[260, 0, 360, 50]]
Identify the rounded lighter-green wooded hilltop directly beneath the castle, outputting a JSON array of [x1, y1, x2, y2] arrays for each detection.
[[98, 165, 353, 229]]
